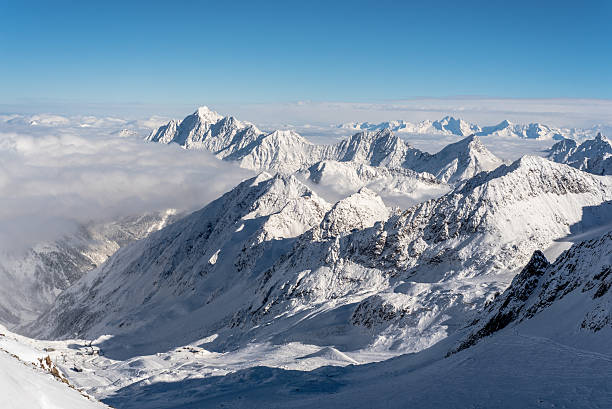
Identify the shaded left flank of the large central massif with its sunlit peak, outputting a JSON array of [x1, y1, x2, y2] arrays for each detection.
[[25, 174, 331, 342]]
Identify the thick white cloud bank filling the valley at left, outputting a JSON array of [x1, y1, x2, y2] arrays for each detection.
[[0, 131, 251, 251]]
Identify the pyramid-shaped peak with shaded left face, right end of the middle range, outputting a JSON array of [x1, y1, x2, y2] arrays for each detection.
[[413, 135, 503, 183]]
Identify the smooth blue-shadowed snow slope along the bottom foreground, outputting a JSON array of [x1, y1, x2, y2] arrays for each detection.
[[104, 332, 612, 409]]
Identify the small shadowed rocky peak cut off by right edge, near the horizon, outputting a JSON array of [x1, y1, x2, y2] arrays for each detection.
[[548, 133, 612, 175]]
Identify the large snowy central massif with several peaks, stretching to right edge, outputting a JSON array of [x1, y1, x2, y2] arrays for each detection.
[[28, 157, 612, 354]]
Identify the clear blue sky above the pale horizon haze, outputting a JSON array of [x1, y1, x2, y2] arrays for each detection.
[[0, 0, 612, 109]]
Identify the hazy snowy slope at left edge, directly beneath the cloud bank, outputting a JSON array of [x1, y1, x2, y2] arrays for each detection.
[[0, 210, 177, 326]]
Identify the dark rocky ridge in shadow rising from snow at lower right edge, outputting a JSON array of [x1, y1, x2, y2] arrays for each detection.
[[455, 232, 612, 351]]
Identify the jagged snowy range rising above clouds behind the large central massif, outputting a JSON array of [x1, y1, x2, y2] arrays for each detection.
[[147, 107, 502, 182]]
